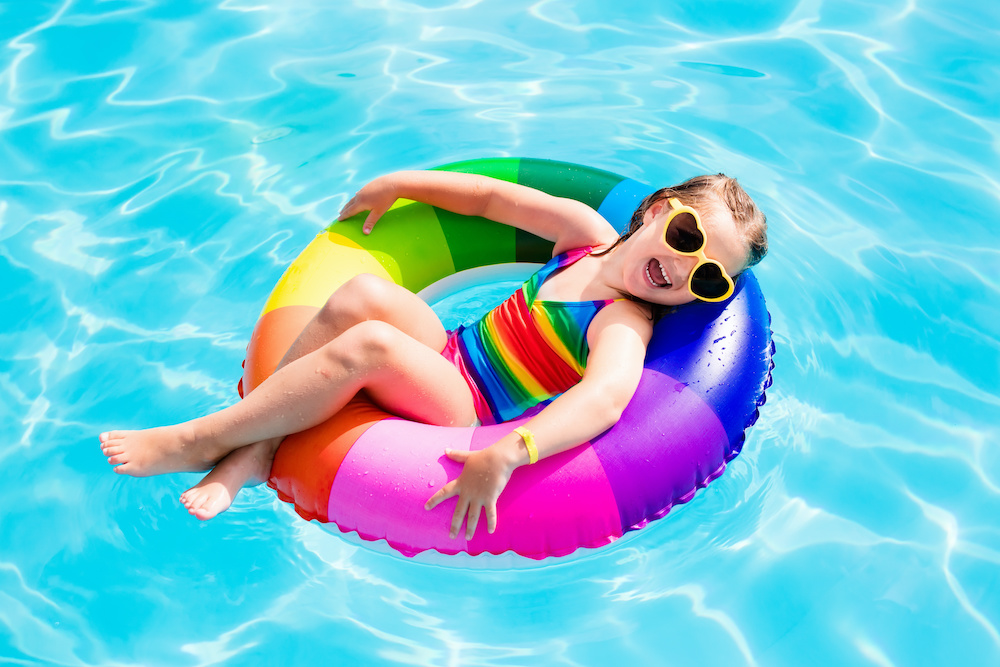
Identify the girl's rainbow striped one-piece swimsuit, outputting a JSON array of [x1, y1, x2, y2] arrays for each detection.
[[441, 247, 615, 424]]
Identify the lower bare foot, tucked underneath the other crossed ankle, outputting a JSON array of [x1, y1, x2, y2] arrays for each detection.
[[181, 438, 281, 521]]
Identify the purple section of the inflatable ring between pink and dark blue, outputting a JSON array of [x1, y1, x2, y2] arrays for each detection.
[[593, 369, 729, 531]]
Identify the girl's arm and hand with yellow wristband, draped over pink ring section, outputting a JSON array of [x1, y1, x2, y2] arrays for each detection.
[[425, 301, 653, 539]]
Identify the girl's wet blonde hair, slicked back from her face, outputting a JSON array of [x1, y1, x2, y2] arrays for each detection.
[[598, 174, 767, 278]]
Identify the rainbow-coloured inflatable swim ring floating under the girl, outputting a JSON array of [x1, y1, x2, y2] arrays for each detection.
[[240, 158, 774, 559]]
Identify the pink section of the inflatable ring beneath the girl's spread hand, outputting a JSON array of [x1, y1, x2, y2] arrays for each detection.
[[329, 419, 622, 558]]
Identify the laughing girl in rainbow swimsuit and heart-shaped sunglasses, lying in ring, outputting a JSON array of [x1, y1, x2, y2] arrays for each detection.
[[100, 171, 767, 538]]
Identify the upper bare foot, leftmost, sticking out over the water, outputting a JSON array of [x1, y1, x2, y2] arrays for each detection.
[[100, 423, 225, 477]]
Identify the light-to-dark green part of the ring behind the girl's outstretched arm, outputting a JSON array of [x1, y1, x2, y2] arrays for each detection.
[[328, 158, 622, 292]]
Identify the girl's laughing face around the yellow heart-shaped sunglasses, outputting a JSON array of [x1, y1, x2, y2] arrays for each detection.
[[622, 194, 747, 306]]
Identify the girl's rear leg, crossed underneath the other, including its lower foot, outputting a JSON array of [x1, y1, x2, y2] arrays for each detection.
[[181, 274, 447, 521]]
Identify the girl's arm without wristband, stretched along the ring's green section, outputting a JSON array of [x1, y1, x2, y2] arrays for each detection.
[[337, 171, 618, 254]]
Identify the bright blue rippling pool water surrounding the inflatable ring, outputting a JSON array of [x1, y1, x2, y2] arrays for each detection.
[[0, 0, 1000, 667]]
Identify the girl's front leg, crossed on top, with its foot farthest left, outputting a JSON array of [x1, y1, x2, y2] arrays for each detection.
[[102, 280, 475, 475]]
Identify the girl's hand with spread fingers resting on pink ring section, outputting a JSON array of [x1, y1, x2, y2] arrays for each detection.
[[424, 445, 517, 540]]
